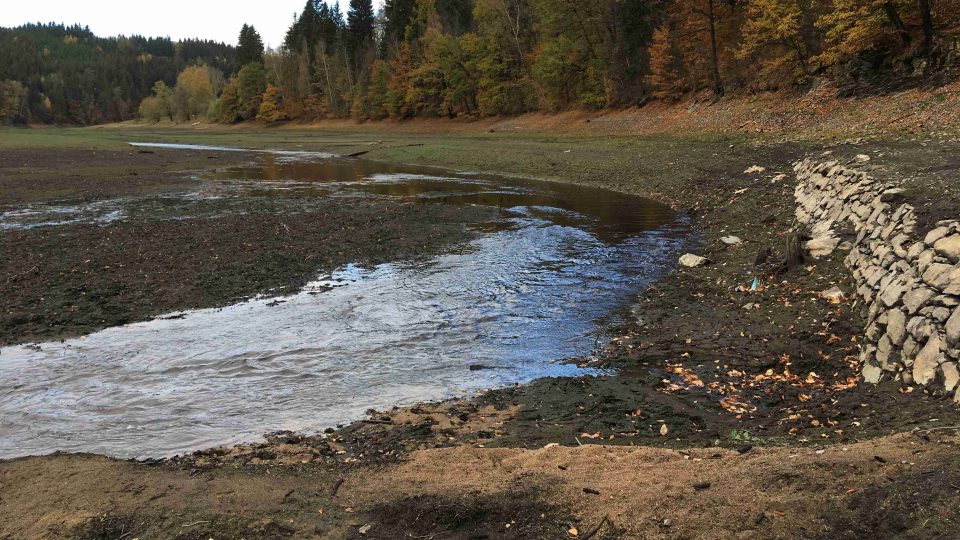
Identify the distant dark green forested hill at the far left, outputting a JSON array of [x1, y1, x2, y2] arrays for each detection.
[[0, 24, 237, 125]]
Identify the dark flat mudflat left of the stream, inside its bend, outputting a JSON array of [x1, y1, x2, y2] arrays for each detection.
[[0, 149, 498, 345]]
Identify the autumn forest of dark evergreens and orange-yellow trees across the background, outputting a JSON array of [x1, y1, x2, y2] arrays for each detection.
[[0, 0, 960, 124]]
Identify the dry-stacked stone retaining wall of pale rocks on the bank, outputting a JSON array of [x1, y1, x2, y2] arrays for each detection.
[[794, 157, 960, 403]]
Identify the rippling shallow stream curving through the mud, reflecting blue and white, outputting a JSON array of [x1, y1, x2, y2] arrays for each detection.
[[0, 149, 685, 458]]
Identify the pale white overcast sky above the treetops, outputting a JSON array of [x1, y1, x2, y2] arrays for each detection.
[[0, 0, 382, 47]]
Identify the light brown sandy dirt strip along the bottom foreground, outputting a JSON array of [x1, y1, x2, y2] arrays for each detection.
[[0, 431, 960, 539]]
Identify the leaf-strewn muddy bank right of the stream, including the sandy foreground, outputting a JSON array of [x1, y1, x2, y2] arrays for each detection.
[[0, 125, 960, 538]]
